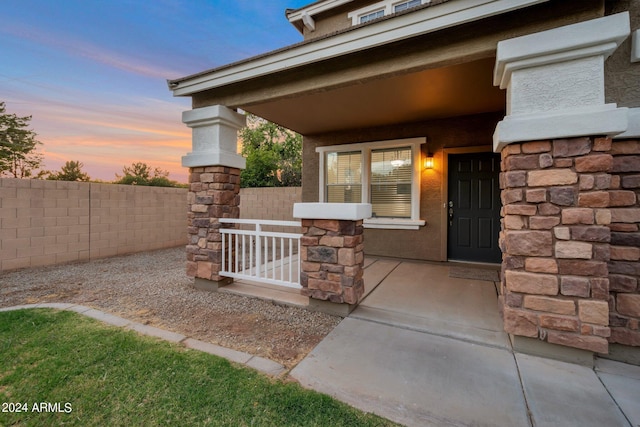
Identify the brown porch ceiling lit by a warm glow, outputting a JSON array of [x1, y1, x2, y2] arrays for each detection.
[[242, 58, 506, 135]]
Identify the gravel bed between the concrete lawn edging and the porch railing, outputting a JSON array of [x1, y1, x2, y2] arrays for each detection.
[[0, 247, 341, 368]]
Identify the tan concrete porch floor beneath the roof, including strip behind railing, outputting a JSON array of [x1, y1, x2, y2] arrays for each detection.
[[220, 257, 509, 348]]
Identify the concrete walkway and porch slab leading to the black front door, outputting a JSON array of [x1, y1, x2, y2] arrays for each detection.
[[290, 260, 640, 427]]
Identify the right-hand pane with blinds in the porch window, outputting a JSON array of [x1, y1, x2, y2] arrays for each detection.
[[370, 147, 413, 218]]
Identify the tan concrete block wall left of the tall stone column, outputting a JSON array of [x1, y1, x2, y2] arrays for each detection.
[[0, 178, 187, 271]]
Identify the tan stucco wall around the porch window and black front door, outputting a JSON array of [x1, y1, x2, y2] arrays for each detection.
[[302, 112, 504, 261]]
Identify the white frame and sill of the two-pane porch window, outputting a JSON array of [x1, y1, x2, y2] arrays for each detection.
[[316, 137, 427, 230]]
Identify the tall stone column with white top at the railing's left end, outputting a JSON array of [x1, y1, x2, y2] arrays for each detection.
[[182, 105, 246, 290]]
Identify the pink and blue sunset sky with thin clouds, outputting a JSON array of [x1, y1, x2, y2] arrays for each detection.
[[0, 0, 311, 182]]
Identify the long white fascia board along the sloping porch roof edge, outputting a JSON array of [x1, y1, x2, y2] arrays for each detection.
[[171, 0, 549, 96]]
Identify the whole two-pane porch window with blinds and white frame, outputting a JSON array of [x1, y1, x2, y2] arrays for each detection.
[[316, 138, 426, 229]]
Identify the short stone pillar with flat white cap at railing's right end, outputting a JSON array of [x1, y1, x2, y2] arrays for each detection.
[[293, 203, 371, 316]]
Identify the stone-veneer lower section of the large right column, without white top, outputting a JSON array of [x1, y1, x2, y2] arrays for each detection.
[[501, 138, 612, 353]]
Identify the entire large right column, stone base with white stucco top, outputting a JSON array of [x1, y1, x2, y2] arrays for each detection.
[[494, 13, 635, 363]]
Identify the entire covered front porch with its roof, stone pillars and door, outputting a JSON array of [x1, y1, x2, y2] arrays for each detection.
[[170, 0, 636, 360]]
